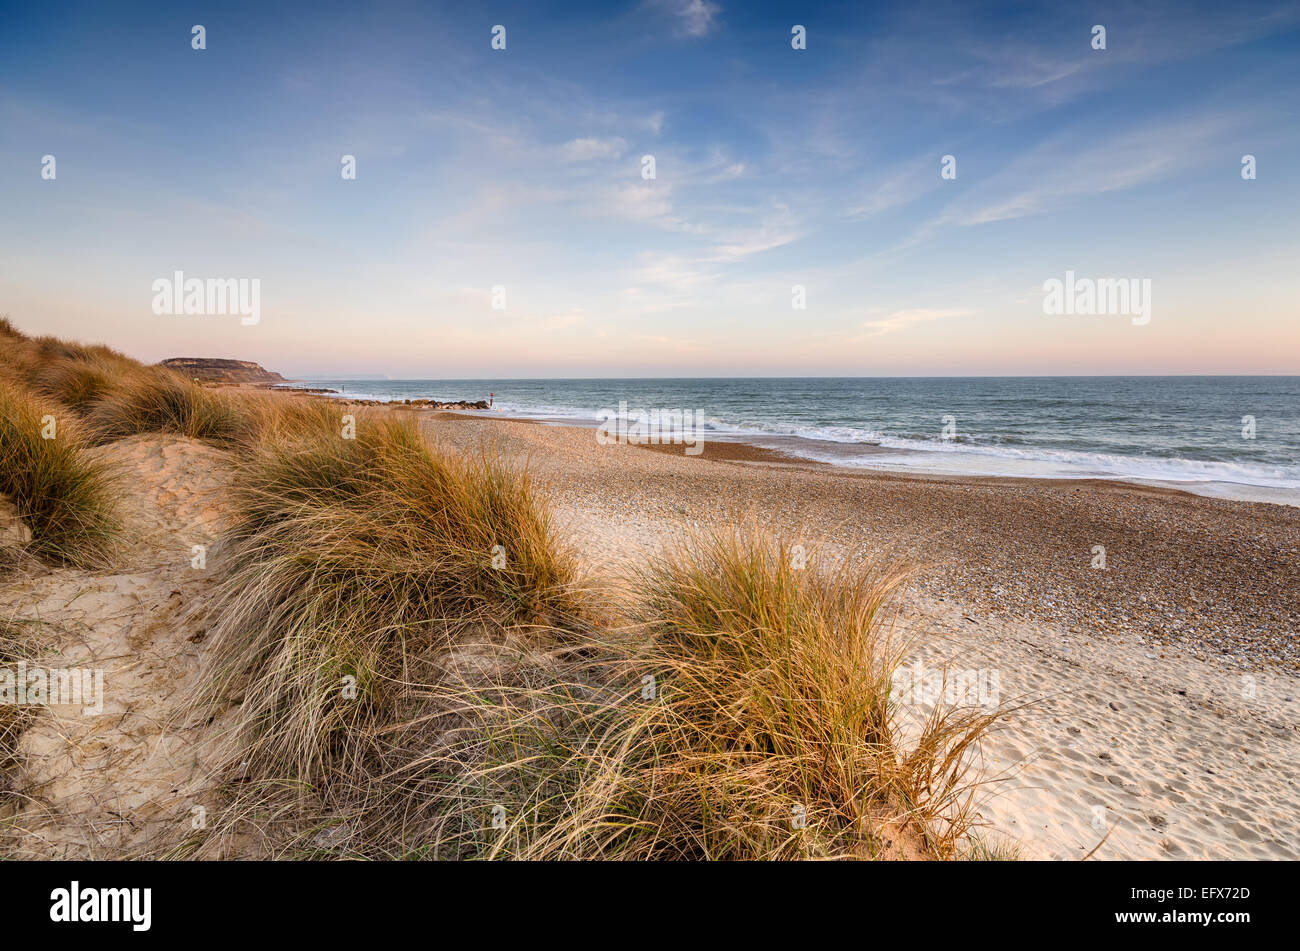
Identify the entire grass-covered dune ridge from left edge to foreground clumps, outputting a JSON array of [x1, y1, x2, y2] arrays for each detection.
[[0, 321, 993, 859]]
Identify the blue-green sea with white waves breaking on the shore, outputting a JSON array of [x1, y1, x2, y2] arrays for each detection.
[[276, 377, 1300, 505]]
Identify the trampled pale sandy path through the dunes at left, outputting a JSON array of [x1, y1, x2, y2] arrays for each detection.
[[0, 437, 225, 859]]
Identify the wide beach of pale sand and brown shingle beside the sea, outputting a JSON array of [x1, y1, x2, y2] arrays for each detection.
[[428, 413, 1300, 859]]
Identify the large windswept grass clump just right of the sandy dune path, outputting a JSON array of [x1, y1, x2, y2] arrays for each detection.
[[197, 416, 576, 789]]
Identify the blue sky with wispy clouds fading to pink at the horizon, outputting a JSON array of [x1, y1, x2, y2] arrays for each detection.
[[0, 0, 1300, 378]]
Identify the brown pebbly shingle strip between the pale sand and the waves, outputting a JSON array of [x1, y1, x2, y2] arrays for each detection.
[[413, 411, 1300, 672]]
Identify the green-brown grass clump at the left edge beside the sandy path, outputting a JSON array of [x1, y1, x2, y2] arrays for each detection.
[[0, 382, 117, 566]]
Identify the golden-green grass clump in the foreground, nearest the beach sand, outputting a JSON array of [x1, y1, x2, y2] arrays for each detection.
[[449, 530, 996, 860]]
